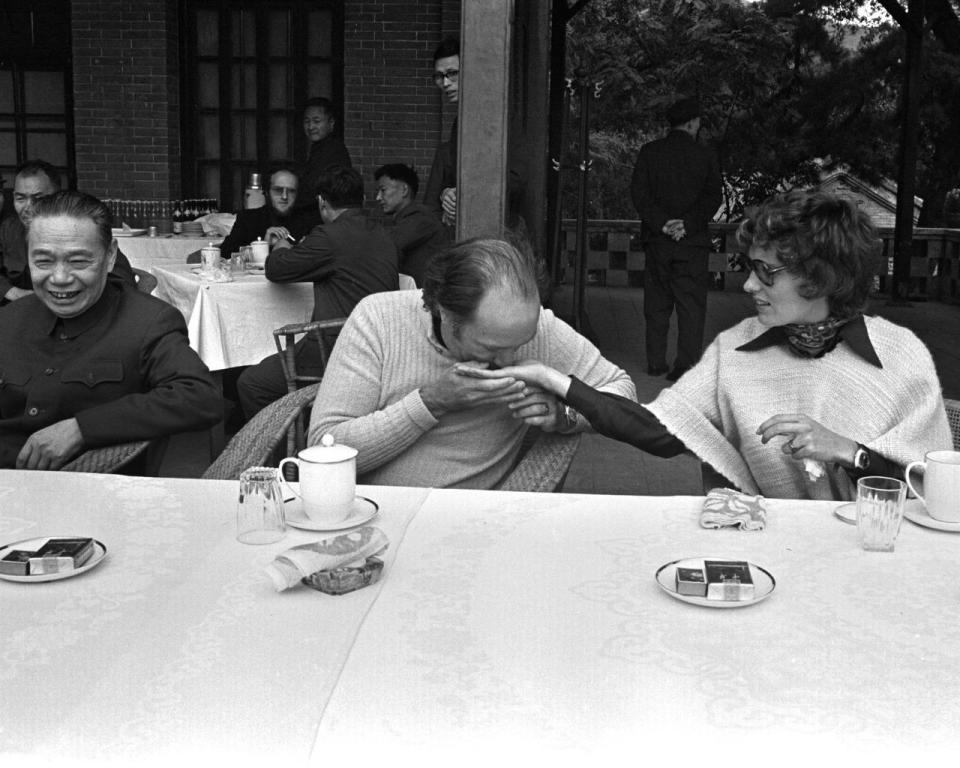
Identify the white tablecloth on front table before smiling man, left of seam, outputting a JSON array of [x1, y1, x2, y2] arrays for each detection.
[[0, 470, 427, 765]]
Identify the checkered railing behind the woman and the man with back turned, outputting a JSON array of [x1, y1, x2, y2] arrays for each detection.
[[563, 219, 960, 303]]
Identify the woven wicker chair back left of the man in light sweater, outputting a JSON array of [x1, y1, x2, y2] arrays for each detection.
[[203, 384, 320, 480]]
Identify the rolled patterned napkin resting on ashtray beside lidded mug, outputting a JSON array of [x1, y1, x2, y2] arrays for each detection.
[[264, 525, 389, 592]]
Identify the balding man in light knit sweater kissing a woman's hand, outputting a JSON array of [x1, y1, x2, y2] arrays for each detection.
[[310, 240, 636, 488]]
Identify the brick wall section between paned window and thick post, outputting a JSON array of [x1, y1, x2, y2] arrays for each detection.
[[344, 0, 460, 203]]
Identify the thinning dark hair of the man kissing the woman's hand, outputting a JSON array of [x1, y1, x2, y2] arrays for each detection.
[[423, 237, 543, 322]]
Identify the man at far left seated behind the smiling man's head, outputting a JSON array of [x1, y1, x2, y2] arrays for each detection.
[[0, 160, 137, 306]]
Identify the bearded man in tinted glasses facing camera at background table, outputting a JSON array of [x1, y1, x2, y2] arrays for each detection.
[[210, 168, 321, 261]]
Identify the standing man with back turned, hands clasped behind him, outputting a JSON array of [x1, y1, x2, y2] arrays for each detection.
[[630, 98, 721, 381]]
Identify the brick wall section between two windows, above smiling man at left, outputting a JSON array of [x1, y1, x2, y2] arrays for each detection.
[[71, 0, 180, 199]]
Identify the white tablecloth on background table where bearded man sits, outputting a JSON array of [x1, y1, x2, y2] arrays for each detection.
[[151, 264, 313, 371]]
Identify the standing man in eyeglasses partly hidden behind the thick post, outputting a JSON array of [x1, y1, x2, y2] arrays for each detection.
[[423, 37, 460, 225]]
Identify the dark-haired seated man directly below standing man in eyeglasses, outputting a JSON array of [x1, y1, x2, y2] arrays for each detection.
[[373, 163, 449, 285]]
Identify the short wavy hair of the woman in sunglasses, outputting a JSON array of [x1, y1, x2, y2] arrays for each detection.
[[737, 189, 882, 319]]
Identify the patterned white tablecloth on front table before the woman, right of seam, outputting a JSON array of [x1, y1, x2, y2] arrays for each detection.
[[314, 491, 960, 766]]
